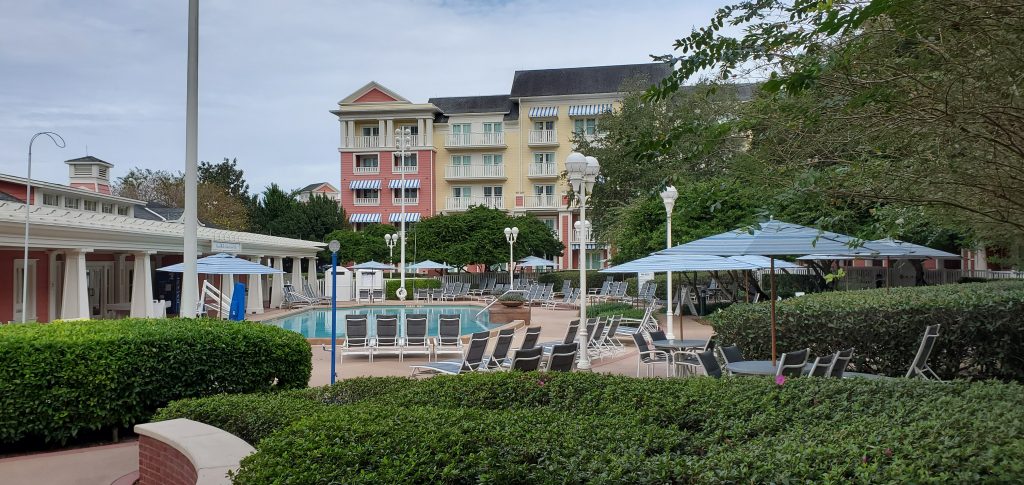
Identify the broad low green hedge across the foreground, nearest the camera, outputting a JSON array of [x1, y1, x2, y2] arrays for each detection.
[[155, 372, 1024, 483]]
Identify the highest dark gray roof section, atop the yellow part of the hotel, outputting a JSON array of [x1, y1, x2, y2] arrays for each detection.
[[511, 62, 672, 98]]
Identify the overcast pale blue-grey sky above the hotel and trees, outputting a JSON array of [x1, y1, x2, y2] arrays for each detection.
[[0, 0, 726, 191]]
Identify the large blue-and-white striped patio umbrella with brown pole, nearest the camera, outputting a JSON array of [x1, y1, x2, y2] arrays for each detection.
[[658, 220, 879, 361]]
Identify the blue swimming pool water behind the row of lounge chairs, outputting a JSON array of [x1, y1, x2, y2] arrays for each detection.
[[265, 305, 499, 339]]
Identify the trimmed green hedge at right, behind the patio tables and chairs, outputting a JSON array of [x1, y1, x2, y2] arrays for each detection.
[[709, 281, 1024, 381]]
